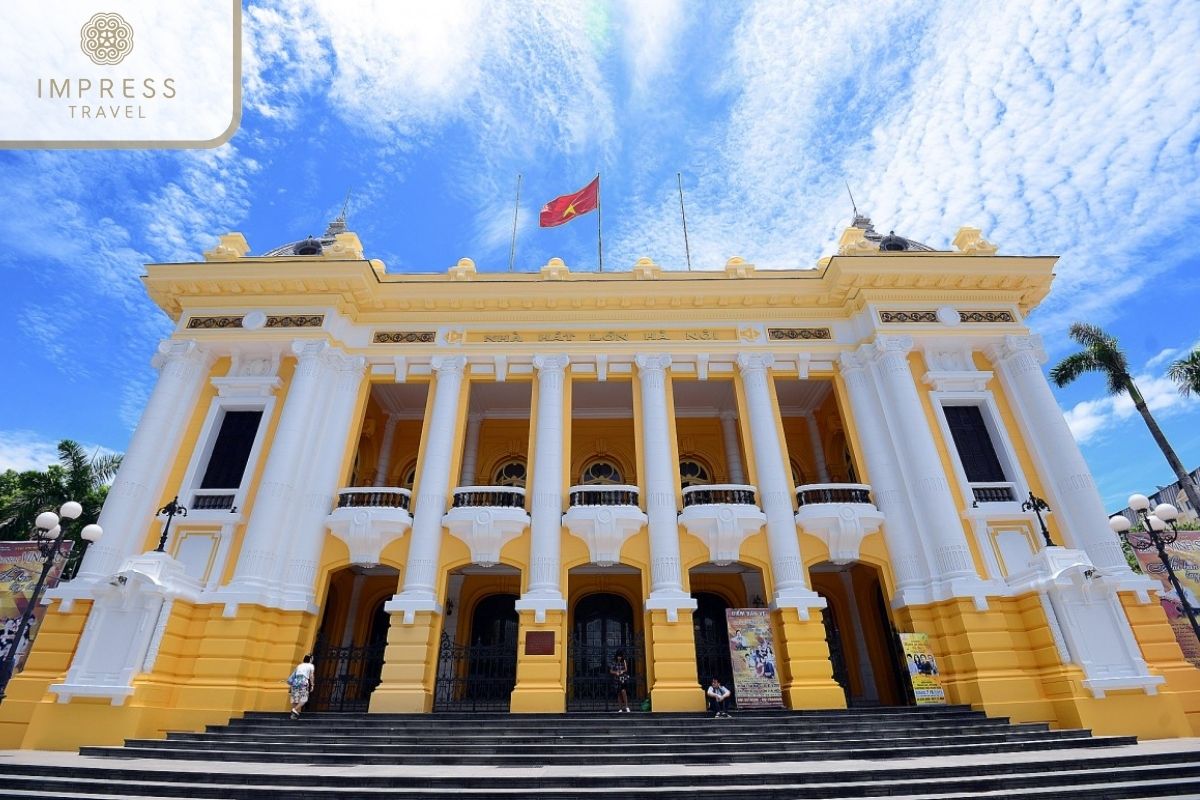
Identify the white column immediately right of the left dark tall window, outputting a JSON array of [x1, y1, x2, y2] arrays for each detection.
[[227, 341, 329, 594]]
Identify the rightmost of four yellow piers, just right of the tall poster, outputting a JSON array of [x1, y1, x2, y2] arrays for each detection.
[[773, 608, 846, 710]]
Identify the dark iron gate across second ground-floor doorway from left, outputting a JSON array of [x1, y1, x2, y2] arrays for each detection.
[[433, 632, 517, 711]]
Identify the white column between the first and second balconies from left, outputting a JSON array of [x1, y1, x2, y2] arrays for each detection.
[[385, 356, 467, 625]]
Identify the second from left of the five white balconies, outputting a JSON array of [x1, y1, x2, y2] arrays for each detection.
[[442, 486, 529, 566]]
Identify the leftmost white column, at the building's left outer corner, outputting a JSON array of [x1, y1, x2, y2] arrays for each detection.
[[79, 339, 212, 582]]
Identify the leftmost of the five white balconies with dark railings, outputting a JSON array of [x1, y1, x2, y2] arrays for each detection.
[[325, 486, 413, 566]]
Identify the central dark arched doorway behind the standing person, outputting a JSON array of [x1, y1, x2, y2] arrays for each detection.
[[566, 593, 646, 711]]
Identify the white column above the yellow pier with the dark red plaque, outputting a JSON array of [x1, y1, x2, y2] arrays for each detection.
[[516, 354, 570, 622]]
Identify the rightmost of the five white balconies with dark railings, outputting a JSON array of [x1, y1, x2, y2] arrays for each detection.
[[796, 483, 883, 564]]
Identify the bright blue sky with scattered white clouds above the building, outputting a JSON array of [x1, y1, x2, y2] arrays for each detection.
[[0, 0, 1200, 510]]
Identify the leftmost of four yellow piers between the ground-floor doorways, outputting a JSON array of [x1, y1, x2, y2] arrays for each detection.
[[370, 612, 442, 714]]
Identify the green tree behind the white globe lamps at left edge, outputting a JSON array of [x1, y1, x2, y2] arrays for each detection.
[[0, 439, 121, 541]]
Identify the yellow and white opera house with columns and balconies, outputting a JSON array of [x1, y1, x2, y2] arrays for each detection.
[[0, 217, 1200, 748]]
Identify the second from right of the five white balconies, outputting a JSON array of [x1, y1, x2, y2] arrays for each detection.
[[679, 483, 767, 565]]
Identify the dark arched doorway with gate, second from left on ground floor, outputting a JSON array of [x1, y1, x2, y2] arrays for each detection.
[[433, 594, 520, 711]]
